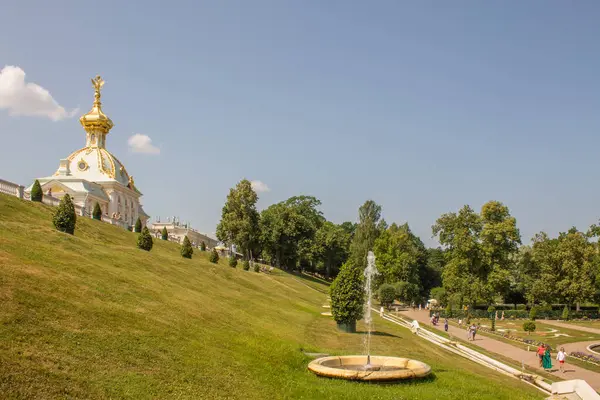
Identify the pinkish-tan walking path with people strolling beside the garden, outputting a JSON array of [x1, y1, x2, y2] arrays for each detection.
[[400, 310, 600, 391]]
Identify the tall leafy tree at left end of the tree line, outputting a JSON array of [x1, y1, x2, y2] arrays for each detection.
[[217, 179, 260, 257]]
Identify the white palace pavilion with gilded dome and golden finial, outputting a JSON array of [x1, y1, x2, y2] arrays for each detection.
[[27, 76, 149, 230]]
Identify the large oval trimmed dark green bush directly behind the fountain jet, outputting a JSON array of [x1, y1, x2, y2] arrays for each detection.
[[329, 263, 365, 331]]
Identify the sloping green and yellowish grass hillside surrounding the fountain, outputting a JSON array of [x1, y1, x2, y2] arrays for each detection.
[[0, 194, 544, 399]]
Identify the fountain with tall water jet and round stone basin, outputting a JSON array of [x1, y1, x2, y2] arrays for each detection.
[[308, 251, 431, 382]]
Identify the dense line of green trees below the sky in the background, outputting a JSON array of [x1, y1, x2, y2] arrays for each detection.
[[217, 180, 600, 315]]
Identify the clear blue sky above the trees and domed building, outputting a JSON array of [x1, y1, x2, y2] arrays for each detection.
[[0, 0, 600, 245]]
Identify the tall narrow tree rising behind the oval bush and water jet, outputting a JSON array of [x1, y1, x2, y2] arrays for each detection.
[[349, 200, 386, 270]]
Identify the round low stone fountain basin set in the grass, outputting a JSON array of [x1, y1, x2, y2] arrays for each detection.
[[308, 356, 431, 382]]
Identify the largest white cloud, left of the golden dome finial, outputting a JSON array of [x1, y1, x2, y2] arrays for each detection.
[[0, 65, 79, 121]]
